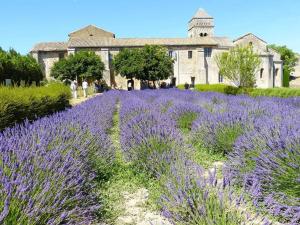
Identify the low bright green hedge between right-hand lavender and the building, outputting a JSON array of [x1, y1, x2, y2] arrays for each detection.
[[177, 84, 300, 97]]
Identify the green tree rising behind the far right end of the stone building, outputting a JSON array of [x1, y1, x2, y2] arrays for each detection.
[[268, 44, 298, 87]]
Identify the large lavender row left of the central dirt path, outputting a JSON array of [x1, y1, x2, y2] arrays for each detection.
[[0, 93, 117, 225]]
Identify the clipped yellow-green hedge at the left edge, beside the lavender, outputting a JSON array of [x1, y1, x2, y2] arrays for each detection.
[[0, 84, 71, 130]]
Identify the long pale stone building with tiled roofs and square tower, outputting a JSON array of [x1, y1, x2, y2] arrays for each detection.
[[31, 9, 283, 88]]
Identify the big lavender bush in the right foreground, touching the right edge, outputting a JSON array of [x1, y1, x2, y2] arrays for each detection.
[[225, 111, 300, 224]]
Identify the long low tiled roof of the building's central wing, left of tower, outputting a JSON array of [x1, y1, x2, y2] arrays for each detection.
[[68, 37, 218, 48]]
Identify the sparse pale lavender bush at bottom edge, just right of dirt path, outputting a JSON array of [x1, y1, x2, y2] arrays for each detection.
[[160, 163, 255, 225]]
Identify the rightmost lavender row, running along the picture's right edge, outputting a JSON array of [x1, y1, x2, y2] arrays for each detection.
[[192, 91, 300, 224]]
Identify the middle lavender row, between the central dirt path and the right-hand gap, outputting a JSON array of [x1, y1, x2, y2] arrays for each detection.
[[120, 91, 253, 225]]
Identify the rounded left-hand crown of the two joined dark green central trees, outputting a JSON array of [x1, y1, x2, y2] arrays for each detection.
[[113, 48, 144, 79]]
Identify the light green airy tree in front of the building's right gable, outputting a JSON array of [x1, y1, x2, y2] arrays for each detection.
[[215, 46, 261, 87]]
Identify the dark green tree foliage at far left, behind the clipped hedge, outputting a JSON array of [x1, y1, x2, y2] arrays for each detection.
[[0, 49, 43, 85]]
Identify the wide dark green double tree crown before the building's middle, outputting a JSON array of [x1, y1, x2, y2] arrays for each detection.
[[113, 45, 173, 85]]
